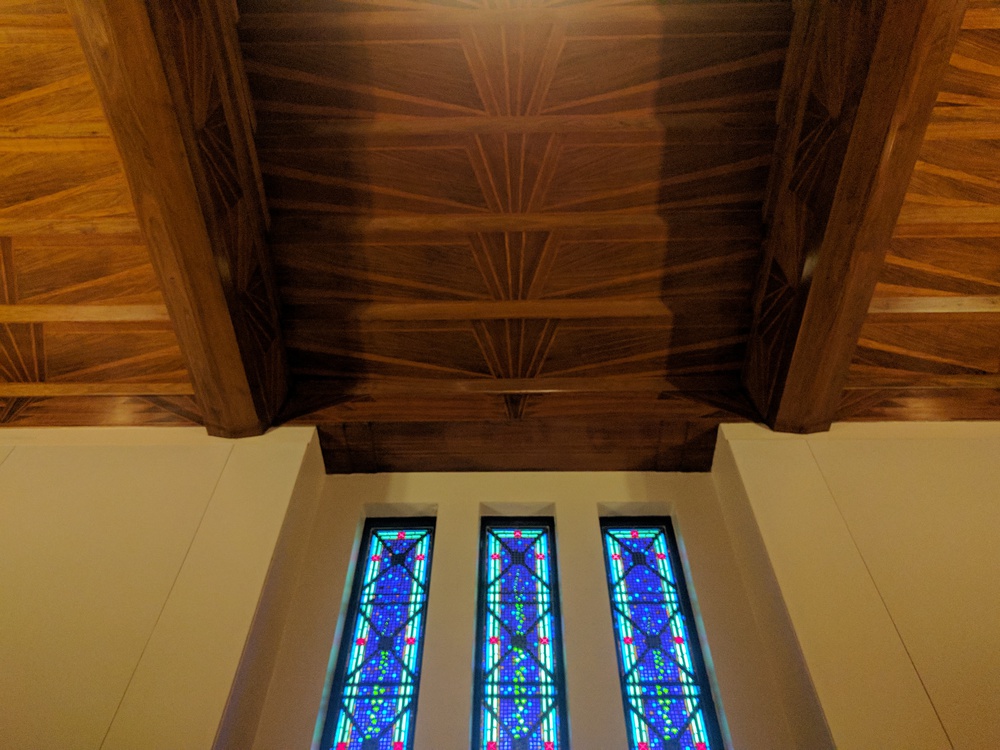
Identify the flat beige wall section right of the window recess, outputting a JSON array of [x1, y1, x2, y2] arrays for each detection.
[[715, 423, 1000, 750]]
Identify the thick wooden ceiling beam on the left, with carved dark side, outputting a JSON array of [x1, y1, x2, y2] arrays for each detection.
[[67, 0, 287, 437]]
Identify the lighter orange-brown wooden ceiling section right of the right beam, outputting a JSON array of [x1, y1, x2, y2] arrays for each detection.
[[841, 0, 1000, 412]]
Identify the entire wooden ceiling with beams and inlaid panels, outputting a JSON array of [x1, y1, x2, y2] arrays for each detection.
[[0, 0, 1000, 472]]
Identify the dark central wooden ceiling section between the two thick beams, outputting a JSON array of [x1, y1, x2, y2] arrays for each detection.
[[240, 0, 791, 471]]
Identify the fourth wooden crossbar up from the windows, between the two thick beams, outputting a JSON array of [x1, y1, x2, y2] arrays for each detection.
[[257, 114, 776, 140]]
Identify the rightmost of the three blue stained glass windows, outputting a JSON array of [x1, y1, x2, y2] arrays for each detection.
[[601, 518, 723, 750]]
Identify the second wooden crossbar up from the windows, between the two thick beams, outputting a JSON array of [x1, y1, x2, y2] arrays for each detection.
[[287, 296, 746, 321]]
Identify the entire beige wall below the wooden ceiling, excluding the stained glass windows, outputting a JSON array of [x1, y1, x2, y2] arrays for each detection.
[[7, 424, 1000, 750]]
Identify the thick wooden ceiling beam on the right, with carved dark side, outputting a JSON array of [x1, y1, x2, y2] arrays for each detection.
[[743, 0, 966, 432]]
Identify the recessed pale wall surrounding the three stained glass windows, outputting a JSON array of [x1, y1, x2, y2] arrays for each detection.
[[253, 472, 829, 750]]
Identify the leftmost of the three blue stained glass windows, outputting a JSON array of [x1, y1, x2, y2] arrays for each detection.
[[320, 518, 434, 750]]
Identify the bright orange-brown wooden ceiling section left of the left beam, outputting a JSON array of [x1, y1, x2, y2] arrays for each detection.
[[0, 0, 199, 426]]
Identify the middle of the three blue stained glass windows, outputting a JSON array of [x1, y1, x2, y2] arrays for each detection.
[[473, 518, 568, 750]]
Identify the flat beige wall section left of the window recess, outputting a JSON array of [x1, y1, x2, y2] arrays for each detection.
[[0, 428, 318, 750]]
